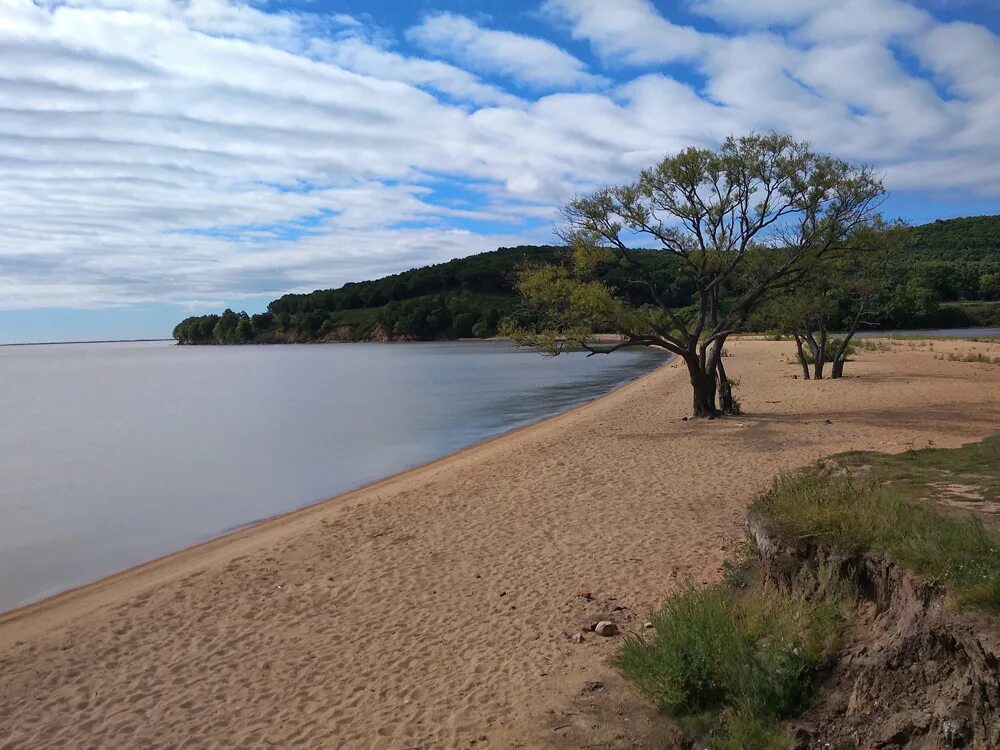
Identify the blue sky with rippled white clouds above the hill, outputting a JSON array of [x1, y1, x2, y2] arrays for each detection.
[[0, 0, 1000, 343]]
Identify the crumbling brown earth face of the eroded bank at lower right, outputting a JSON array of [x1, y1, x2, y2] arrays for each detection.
[[748, 517, 1000, 750]]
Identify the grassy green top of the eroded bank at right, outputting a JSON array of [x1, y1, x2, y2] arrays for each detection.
[[754, 436, 1000, 612]]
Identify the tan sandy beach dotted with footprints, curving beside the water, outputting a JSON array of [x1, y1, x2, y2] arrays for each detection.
[[0, 340, 1000, 748]]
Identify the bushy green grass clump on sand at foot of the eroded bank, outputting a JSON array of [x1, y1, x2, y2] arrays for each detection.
[[619, 584, 843, 748]]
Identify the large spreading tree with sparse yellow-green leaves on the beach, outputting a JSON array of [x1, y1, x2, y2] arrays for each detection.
[[508, 133, 885, 417]]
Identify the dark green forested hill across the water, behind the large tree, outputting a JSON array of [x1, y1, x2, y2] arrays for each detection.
[[174, 216, 1000, 344]]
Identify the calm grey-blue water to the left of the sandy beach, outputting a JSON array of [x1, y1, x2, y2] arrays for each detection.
[[0, 342, 664, 611]]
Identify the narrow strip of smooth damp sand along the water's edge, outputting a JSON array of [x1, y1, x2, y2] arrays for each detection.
[[0, 352, 677, 640]]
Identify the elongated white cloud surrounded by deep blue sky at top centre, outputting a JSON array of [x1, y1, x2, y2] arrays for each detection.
[[406, 13, 604, 88]]
